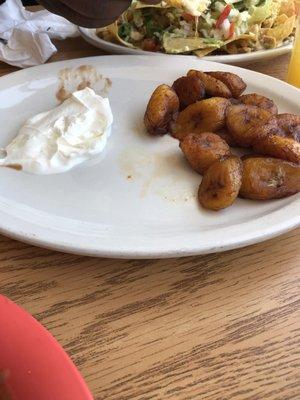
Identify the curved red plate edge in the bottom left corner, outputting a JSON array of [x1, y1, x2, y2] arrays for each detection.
[[0, 295, 93, 400]]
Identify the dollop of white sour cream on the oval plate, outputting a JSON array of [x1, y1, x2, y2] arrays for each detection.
[[0, 88, 113, 174]]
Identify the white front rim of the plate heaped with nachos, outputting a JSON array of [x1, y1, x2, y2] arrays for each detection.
[[78, 27, 292, 64]]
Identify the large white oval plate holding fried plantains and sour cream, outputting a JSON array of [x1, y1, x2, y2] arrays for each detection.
[[0, 56, 300, 258]]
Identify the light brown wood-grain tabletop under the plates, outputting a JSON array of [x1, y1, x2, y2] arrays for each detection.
[[0, 38, 300, 400]]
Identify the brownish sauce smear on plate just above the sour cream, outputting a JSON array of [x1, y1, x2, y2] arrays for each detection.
[[56, 65, 112, 103]]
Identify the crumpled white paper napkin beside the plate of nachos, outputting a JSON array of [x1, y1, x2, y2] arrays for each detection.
[[0, 0, 78, 68]]
